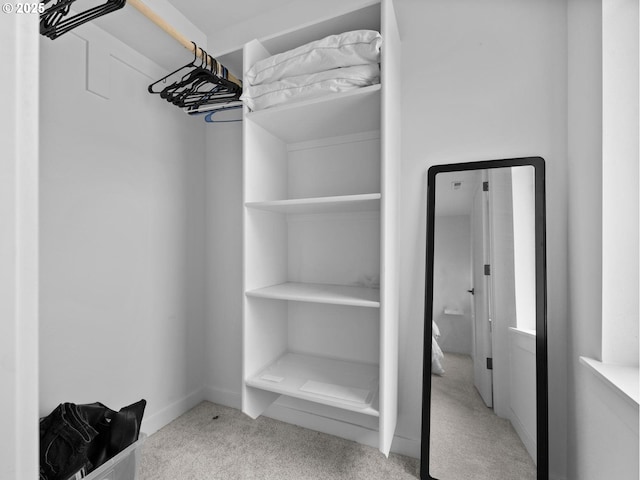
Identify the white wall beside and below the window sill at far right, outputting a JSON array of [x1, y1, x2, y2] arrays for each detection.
[[567, 0, 638, 480]]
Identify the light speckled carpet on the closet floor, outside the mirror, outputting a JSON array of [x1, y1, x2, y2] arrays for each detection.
[[139, 402, 419, 480]]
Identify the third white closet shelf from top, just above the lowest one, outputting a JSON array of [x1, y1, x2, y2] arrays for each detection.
[[246, 282, 380, 308]]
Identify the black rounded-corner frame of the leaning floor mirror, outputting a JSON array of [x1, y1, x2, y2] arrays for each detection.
[[420, 157, 549, 480]]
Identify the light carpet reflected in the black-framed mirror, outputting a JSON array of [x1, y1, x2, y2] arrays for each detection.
[[430, 353, 536, 480]]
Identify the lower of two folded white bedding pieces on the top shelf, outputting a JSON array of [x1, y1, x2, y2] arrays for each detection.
[[240, 63, 380, 110]]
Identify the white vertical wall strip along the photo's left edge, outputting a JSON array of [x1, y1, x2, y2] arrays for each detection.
[[0, 14, 39, 479]]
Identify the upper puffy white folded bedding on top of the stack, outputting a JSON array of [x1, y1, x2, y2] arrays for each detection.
[[243, 30, 382, 86]]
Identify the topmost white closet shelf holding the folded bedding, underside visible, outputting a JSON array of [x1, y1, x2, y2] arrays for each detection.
[[246, 85, 380, 144]]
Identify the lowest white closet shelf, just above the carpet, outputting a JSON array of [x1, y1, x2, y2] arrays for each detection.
[[246, 353, 380, 417]]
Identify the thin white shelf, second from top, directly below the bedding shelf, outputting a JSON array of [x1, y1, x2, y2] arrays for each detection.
[[245, 193, 381, 214]]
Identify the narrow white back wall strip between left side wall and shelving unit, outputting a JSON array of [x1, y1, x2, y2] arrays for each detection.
[[205, 123, 243, 408]]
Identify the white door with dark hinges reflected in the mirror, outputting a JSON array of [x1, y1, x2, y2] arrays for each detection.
[[471, 180, 493, 407]]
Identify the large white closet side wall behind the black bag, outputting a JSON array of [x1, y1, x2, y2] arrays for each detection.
[[40, 25, 205, 432]]
